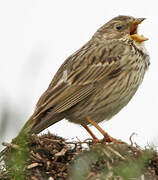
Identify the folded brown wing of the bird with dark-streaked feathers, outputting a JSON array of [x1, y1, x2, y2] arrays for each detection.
[[34, 43, 124, 117]]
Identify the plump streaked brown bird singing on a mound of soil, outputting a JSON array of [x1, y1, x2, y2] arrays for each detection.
[[23, 15, 150, 142]]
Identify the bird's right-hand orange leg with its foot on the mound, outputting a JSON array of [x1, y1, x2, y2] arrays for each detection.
[[87, 117, 124, 144]]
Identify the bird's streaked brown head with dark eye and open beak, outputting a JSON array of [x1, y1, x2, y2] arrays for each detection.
[[94, 16, 148, 43]]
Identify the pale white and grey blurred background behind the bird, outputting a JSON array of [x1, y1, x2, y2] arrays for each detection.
[[0, 0, 158, 150]]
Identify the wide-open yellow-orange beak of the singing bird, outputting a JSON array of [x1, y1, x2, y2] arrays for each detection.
[[129, 18, 148, 42]]
